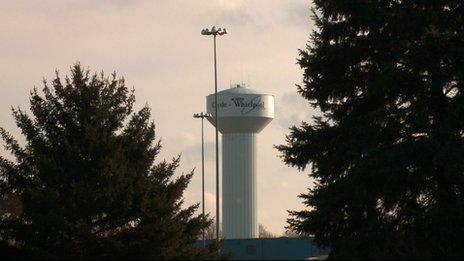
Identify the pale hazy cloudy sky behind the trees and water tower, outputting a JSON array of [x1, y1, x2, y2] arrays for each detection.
[[0, 0, 316, 235]]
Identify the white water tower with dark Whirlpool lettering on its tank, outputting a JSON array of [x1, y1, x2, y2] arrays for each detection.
[[206, 85, 274, 239]]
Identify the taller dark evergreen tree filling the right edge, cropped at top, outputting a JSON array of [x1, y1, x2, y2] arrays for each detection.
[[277, 0, 464, 259]]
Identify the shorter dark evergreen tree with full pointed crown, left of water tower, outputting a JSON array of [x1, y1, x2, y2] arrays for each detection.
[[0, 64, 218, 259]]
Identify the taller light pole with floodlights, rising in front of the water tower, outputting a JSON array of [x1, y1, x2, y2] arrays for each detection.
[[201, 26, 228, 242]]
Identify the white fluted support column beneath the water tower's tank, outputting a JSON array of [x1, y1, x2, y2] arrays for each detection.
[[222, 133, 258, 239]]
